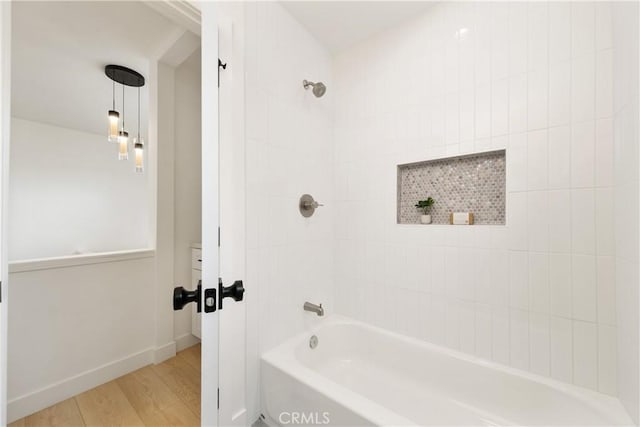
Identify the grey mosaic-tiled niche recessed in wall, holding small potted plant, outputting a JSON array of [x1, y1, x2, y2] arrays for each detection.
[[398, 150, 506, 225]]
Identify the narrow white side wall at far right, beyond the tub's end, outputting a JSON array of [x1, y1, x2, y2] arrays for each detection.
[[612, 2, 640, 423]]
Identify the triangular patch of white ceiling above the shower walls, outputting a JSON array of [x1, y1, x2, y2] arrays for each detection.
[[281, 1, 434, 54]]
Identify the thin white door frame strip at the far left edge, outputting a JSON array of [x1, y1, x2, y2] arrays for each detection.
[[0, 2, 11, 426]]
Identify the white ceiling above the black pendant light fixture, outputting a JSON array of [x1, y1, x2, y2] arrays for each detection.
[[11, 1, 184, 136]]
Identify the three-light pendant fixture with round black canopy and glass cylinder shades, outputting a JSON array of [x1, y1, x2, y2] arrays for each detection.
[[104, 65, 145, 172]]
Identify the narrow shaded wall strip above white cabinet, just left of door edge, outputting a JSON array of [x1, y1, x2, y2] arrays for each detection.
[[173, 50, 202, 344]]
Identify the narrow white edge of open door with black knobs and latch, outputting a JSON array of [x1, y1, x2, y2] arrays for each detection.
[[200, 2, 220, 427]]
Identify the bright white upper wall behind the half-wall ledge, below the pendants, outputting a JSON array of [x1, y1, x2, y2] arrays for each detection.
[[9, 118, 151, 260]]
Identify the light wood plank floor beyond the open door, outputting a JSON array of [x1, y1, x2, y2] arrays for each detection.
[[9, 344, 200, 427]]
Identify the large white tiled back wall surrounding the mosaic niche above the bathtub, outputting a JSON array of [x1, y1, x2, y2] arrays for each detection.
[[332, 2, 616, 394]]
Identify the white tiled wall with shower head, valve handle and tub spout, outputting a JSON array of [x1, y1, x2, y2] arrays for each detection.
[[245, 2, 334, 351]]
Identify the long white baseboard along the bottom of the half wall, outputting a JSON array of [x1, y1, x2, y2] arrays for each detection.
[[7, 348, 156, 422]]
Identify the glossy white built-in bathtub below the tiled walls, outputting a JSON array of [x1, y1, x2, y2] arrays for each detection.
[[261, 316, 633, 426]]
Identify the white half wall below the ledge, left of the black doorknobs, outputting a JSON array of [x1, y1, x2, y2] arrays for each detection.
[[8, 251, 156, 421]]
